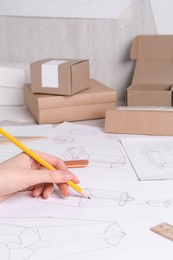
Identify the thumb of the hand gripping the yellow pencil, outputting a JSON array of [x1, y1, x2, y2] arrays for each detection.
[[28, 170, 74, 185]]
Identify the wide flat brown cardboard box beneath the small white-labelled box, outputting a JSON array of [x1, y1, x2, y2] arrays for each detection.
[[24, 79, 117, 124]]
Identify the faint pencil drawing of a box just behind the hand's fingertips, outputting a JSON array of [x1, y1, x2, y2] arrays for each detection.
[[62, 146, 126, 168]]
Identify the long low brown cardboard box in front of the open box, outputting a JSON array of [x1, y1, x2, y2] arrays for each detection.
[[105, 107, 173, 136]]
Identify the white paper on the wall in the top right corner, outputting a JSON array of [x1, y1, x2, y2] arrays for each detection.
[[150, 0, 173, 34]]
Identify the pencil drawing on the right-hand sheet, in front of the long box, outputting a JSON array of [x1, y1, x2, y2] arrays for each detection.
[[141, 145, 173, 170]]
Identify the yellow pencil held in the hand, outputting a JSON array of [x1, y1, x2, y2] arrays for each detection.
[[0, 128, 90, 199]]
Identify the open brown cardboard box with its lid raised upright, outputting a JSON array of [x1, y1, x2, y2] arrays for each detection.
[[126, 35, 173, 106]]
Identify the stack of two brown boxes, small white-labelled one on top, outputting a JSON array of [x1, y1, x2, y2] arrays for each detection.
[[24, 59, 117, 124]]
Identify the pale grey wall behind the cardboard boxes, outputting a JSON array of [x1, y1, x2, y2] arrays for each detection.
[[0, 0, 156, 100]]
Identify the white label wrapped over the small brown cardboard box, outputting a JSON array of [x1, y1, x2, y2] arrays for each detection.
[[41, 60, 67, 88]]
